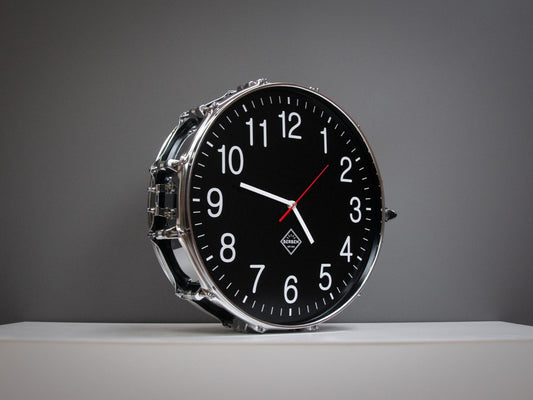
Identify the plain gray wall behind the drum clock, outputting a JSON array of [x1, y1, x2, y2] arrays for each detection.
[[0, 1, 533, 324]]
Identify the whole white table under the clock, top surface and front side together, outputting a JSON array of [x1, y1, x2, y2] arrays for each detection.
[[0, 321, 533, 400]]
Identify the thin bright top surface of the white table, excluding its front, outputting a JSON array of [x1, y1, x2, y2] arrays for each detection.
[[0, 321, 533, 345]]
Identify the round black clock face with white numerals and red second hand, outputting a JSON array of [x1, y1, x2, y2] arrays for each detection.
[[188, 86, 382, 326]]
